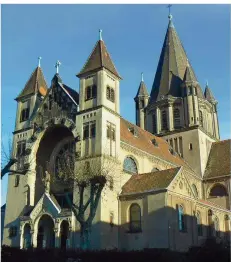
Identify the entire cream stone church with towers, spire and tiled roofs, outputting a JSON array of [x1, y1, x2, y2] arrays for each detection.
[[2, 15, 231, 251]]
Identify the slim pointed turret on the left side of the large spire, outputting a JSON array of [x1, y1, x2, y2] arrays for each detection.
[[134, 73, 149, 129]]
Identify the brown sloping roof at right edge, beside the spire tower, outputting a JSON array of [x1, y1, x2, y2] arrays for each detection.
[[204, 139, 231, 179]]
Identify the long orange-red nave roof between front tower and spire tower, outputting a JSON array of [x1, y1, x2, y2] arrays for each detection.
[[120, 117, 193, 172]]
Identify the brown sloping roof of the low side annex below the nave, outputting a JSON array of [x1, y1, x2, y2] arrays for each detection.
[[121, 167, 180, 195]]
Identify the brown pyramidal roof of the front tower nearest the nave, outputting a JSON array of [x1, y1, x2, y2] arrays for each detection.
[[77, 40, 121, 78]]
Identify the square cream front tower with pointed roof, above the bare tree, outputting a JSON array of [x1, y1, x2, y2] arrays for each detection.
[[77, 30, 121, 157]]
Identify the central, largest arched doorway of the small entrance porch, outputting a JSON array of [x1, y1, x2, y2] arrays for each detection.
[[37, 215, 55, 248]]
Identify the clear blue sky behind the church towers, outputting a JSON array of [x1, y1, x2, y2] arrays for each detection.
[[1, 4, 230, 203]]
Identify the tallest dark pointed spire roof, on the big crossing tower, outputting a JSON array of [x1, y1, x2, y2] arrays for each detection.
[[150, 15, 197, 101]]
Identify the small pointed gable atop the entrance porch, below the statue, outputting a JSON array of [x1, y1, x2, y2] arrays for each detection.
[[30, 193, 61, 220]]
